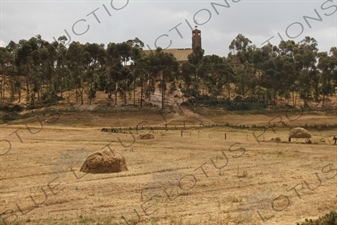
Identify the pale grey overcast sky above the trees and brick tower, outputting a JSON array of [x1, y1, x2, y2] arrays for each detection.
[[0, 0, 337, 56]]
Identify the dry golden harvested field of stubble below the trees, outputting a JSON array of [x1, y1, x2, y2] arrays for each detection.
[[0, 107, 337, 225]]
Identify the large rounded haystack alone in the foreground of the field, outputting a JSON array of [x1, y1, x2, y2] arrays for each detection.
[[80, 149, 128, 173]]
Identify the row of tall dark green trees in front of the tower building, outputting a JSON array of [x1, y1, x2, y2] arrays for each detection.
[[0, 34, 337, 110]]
